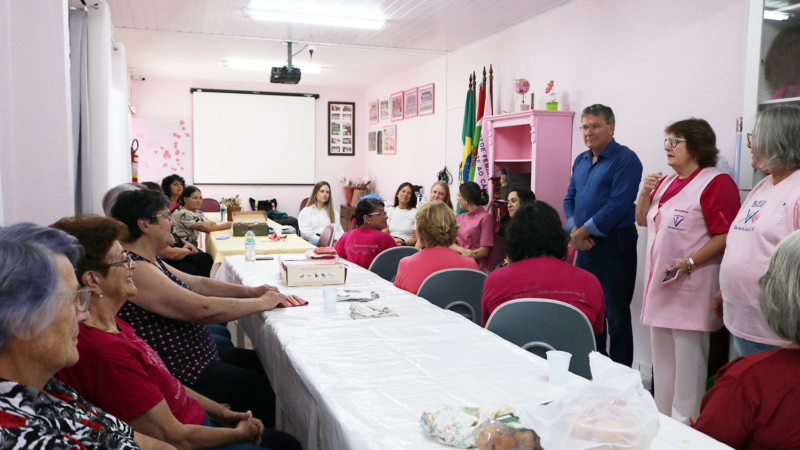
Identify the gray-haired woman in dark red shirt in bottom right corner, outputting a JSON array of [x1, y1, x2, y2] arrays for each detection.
[[691, 231, 800, 450]]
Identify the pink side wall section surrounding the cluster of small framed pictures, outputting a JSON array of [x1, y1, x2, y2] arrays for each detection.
[[364, 56, 446, 202]]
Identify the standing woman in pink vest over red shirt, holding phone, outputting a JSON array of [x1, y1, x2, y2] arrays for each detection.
[[636, 119, 739, 423]]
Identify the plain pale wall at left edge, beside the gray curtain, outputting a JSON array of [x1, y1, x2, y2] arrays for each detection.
[[0, 0, 75, 224]]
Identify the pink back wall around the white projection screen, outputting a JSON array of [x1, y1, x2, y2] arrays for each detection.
[[131, 78, 368, 216]]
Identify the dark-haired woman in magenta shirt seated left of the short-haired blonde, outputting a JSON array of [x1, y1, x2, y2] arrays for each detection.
[[334, 198, 397, 269]]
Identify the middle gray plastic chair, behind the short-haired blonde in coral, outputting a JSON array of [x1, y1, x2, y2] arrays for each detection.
[[417, 269, 486, 325]]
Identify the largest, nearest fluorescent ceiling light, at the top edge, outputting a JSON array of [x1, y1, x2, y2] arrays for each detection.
[[244, 0, 386, 30]]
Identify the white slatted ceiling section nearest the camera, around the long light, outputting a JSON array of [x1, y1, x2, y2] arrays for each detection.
[[108, 0, 577, 52]]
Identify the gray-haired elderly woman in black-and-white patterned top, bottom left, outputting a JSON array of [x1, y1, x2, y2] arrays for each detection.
[[0, 223, 173, 450]]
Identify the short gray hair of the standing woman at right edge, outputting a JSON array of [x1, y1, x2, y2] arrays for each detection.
[[751, 105, 800, 171]]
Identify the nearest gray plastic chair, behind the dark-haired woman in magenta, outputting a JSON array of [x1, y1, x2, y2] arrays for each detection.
[[486, 298, 597, 379]]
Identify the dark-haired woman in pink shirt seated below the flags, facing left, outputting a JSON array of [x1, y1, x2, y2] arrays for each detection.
[[450, 181, 494, 271]]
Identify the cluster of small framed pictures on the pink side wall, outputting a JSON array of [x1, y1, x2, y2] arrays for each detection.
[[368, 83, 436, 155]]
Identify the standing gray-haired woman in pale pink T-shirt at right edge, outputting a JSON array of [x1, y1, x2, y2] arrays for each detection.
[[714, 106, 800, 356]]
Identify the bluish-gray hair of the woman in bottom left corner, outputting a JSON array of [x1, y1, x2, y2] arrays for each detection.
[[0, 223, 83, 352]]
